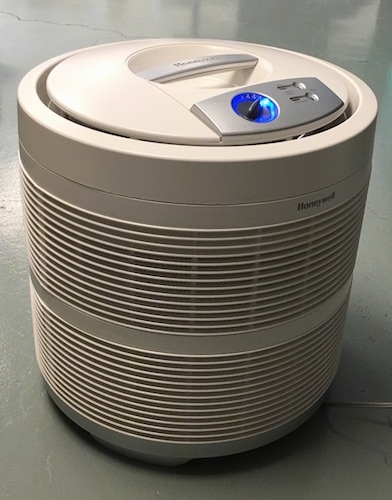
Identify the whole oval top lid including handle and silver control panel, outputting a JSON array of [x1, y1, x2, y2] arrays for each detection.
[[46, 40, 348, 145]]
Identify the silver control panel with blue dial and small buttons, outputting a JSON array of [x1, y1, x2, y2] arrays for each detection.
[[191, 77, 345, 144]]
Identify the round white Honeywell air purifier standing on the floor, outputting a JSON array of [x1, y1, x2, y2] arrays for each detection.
[[18, 39, 377, 464]]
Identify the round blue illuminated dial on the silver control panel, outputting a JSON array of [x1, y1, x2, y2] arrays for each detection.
[[231, 92, 279, 123]]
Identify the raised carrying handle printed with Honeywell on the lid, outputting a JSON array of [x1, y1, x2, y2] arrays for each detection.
[[136, 54, 259, 83]]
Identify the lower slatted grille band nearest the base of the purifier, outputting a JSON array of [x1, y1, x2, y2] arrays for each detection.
[[33, 292, 347, 443]]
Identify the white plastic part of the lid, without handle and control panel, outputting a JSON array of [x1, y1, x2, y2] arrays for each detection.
[[47, 40, 348, 145]]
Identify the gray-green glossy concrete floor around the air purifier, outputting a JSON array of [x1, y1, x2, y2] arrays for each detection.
[[0, 0, 392, 500]]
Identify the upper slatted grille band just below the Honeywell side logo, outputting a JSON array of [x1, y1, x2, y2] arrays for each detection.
[[22, 169, 366, 335]]
